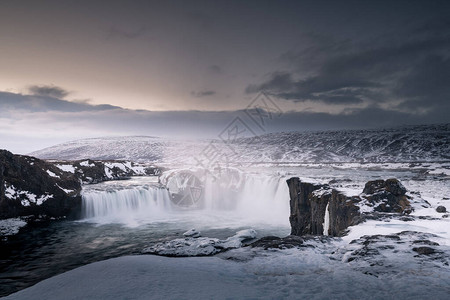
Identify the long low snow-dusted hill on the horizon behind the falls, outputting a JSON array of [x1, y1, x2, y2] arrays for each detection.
[[30, 124, 450, 164]]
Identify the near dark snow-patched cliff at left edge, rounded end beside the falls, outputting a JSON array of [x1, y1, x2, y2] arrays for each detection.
[[0, 150, 81, 219]]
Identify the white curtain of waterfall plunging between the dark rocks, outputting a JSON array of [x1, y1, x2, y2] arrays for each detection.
[[82, 175, 289, 227]]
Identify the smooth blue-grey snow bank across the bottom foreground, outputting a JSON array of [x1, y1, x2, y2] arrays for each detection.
[[5, 242, 450, 300]]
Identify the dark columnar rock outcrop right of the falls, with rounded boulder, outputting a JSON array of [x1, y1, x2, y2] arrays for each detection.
[[287, 177, 412, 236]]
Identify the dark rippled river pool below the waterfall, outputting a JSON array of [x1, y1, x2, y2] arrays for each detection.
[[0, 221, 285, 297]]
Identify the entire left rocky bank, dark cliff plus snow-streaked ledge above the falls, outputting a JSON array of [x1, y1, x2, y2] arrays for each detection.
[[0, 150, 160, 221]]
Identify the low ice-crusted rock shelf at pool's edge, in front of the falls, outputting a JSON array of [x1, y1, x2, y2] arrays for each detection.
[[142, 229, 256, 256]]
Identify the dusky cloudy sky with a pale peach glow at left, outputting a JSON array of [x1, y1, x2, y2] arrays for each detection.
[[0, 0, 450, 153]]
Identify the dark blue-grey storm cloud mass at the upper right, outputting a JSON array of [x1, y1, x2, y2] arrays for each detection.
[[246, 22, 450, 111]]
